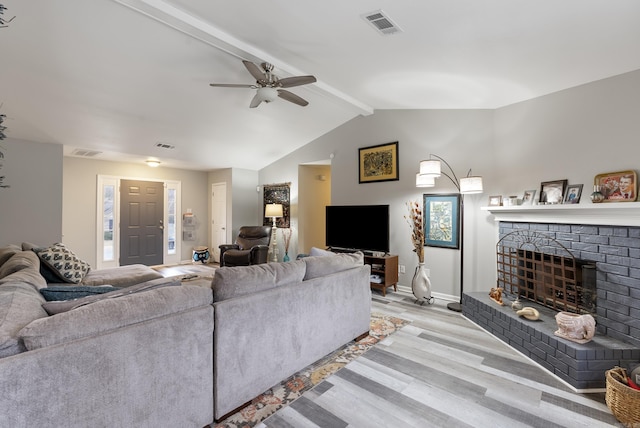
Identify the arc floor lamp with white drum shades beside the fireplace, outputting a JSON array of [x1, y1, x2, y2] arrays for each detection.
[[416, 154, 483, 312]]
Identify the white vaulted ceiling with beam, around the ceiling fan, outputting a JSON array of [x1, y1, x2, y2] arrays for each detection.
[[0, 0, 640, 170]]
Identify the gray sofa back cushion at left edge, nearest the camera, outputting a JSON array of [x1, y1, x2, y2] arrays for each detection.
[[0, 282, 47, 358]]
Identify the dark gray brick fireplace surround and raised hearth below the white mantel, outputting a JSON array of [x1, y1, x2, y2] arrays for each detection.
[[462, 221, 640, 392]]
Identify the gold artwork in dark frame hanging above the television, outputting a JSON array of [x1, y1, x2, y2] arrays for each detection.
[[358, 141, 400, 183]]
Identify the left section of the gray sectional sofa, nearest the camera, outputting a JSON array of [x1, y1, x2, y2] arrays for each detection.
[[0, 246, 213, 428]]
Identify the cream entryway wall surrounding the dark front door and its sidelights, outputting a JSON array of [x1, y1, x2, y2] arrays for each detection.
[[62, 157, 209, 266]]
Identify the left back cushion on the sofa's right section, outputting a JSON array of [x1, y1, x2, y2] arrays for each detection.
[[212, 260, 306, 302]]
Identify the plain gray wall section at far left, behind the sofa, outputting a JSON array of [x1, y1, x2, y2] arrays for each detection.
[[0, 138, 62, 245]]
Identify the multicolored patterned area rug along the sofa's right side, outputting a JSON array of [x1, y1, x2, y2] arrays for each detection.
[[214, 313, 410, 428]]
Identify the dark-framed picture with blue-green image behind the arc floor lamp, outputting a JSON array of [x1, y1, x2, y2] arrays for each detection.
[[423, 194, 460, 249]]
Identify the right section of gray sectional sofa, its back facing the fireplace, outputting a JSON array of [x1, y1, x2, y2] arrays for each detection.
[[213, 253, 371, 420]]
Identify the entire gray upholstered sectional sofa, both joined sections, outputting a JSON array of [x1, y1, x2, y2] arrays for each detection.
[[0, 246, 371, 428]]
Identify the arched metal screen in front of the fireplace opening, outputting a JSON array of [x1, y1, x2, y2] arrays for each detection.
[[496, 230, 595, 314]]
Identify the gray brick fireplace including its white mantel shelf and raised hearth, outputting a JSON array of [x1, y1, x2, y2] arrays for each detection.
[[462, 203, 640, 391]]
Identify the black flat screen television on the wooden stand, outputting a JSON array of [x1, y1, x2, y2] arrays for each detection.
[[325, 205, 389, 253]]
